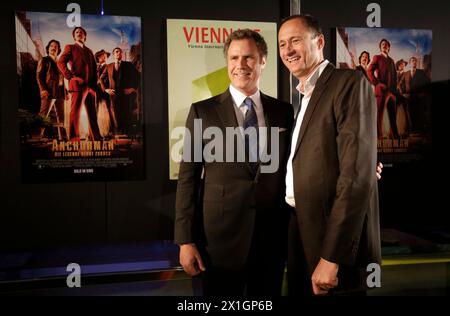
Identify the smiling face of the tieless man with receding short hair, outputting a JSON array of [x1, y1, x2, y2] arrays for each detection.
[[278, 19, 325, 80]]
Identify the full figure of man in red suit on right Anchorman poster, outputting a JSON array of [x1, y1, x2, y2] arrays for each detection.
[[367, 38, 398, 138]]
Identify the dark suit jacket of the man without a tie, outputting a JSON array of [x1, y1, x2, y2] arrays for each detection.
[[292, 64, 380, 274]]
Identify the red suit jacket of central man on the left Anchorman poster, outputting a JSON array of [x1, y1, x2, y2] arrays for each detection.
[[58, 44, 97, 91]]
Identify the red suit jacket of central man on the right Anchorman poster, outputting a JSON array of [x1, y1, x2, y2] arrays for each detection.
[[367, 54, 397, 96]]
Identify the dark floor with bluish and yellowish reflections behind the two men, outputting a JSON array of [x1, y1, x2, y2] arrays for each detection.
[[0, 230, 450, 296]]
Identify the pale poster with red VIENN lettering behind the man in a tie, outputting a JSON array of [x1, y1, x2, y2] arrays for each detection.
[[167, 19, 278, 180]]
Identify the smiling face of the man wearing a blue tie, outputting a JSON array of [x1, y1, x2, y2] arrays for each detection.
[[227, 39, 266, 96]]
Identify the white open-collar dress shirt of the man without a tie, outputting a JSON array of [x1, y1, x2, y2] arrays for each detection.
[[285, 60, 329, 207]]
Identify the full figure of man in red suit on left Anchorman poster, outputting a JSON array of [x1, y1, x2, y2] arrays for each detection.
[[58, 26, 101, 141]]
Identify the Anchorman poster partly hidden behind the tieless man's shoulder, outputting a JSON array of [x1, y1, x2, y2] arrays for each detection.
[[336, 27, 432, 162]]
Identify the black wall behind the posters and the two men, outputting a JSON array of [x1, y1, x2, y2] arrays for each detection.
[[0, 0, 450, 251]]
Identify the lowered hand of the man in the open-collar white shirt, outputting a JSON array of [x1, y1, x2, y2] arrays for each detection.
[[311, 258, 339, 295]]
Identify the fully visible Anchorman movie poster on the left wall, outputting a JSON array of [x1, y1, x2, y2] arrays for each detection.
[[15, 12, 144, 183]]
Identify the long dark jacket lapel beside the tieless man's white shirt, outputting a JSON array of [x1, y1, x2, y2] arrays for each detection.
[[293, 63, 334, 158]]
